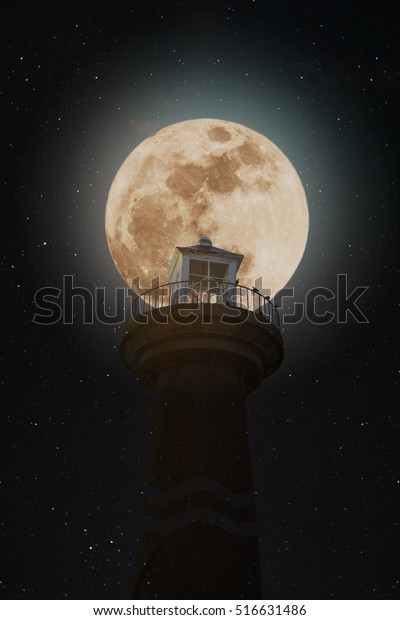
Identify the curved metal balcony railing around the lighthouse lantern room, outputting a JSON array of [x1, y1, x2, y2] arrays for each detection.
[[131, 279, 280, 329]]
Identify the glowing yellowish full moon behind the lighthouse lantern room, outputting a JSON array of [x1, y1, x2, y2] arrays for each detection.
[[106, 119, 308, 296]]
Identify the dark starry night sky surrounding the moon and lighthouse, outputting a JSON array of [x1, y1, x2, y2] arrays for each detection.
[[0, 0, 400, 599]]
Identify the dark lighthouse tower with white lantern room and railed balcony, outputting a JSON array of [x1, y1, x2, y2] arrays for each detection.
[[121, 237, 283, 599]]
